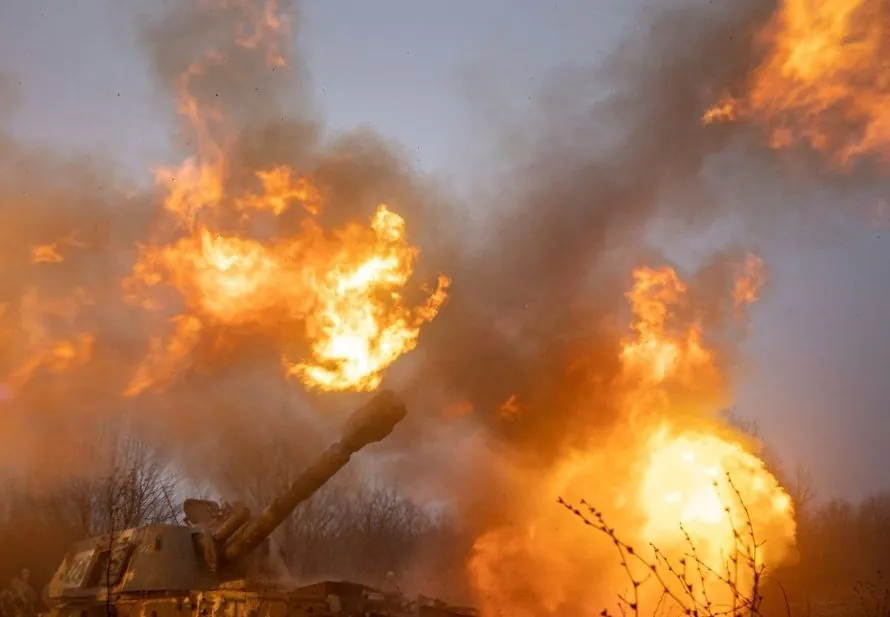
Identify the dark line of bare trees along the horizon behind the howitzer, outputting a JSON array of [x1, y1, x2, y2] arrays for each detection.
[[0, 414, 890, 617]]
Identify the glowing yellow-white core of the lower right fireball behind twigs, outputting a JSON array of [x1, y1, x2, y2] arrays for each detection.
[[640, 427, 795, 606]]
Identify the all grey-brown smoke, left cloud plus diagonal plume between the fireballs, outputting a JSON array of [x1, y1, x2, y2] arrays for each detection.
[[0, 2, 774, 524]]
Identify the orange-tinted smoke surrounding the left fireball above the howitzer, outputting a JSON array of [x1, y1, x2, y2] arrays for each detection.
[[0, 2, 448, 482]]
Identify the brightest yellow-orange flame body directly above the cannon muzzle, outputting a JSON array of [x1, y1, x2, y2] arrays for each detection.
[[126, 170, 449, 395]]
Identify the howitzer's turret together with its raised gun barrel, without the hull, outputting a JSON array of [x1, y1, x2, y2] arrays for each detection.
[[46, 391, 407, 617]]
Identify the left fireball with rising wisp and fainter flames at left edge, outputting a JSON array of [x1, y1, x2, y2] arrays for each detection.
[[3, 0, 450, 396]]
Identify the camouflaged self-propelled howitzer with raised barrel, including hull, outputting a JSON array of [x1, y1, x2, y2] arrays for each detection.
[[38, 391, 420, 617]]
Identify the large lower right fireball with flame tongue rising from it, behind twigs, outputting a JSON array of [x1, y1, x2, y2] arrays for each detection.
[[468, 258, 795, 617]]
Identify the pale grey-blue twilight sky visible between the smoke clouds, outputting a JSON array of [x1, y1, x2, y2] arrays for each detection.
[[0, 0, 890, 497]]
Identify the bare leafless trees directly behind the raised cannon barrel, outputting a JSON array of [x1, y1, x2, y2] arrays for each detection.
[[211, 418, 450, 585]]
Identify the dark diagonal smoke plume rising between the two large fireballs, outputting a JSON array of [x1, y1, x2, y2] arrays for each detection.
[[384, 2, 775, 516]]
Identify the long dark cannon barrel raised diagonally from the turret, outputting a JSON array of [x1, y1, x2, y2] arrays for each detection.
[[223, 390, 408, 562]]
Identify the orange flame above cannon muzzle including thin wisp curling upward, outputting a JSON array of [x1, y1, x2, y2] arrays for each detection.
[[124, 0, 449, 396]]
